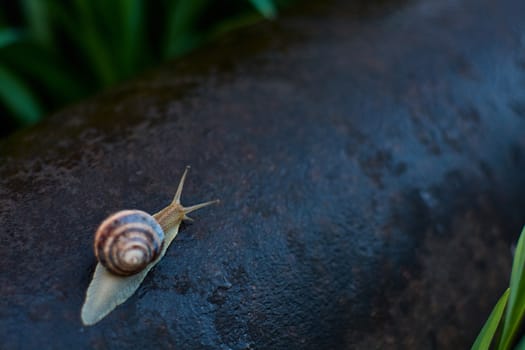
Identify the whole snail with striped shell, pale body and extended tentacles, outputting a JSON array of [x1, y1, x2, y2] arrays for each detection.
[[80, 166, 219, 325]]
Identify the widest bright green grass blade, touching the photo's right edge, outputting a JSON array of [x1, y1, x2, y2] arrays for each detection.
[[498, 227, 525, 350]]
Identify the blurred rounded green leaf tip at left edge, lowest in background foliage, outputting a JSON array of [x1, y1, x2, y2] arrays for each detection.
[[0, 66, 41, 125]]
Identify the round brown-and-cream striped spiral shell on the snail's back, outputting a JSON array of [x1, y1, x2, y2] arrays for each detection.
[[95, 210, 164, 276]]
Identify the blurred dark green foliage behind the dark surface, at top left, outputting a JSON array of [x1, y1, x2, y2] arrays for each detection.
[[0, 0, 291, 135]]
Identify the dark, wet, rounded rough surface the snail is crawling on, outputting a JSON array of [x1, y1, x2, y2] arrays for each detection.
[[0, 0, 525, 349]]
